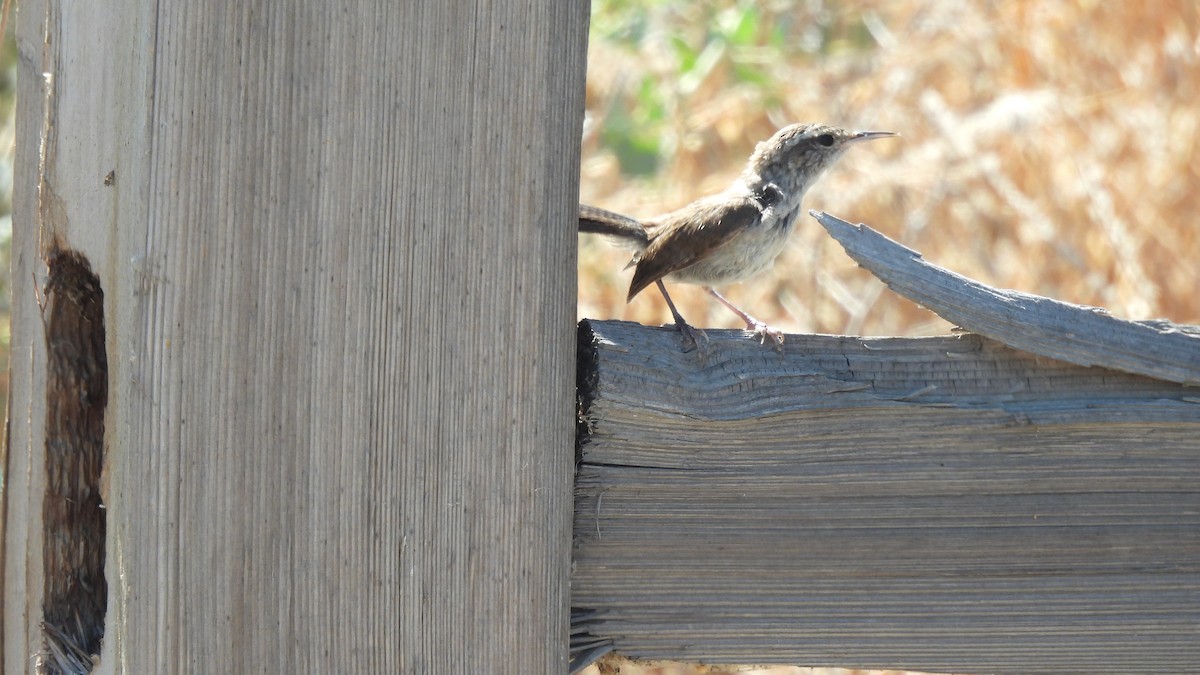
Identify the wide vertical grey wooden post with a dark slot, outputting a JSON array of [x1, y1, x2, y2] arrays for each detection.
[[4, 0, 587, 673]]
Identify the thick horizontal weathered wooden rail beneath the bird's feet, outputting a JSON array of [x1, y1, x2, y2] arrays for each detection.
[[572, 321, 1200, 673]]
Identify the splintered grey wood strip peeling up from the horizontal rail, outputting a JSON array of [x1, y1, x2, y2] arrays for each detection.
[[809, 211, 1200, 384]]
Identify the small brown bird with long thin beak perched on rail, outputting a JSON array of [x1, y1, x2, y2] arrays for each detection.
[[580, 124, 898, 345]]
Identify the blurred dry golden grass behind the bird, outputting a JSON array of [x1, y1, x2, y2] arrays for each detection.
[[578, 0, 1200, 335]]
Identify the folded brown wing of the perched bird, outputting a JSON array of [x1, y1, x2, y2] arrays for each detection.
[[628, 195, 769, 300]]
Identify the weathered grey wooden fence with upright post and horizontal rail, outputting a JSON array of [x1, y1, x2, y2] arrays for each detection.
[[0, 0, 1200, 674]]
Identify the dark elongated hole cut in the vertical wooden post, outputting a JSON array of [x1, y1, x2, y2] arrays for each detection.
[[37, 250, 108, 673]]
